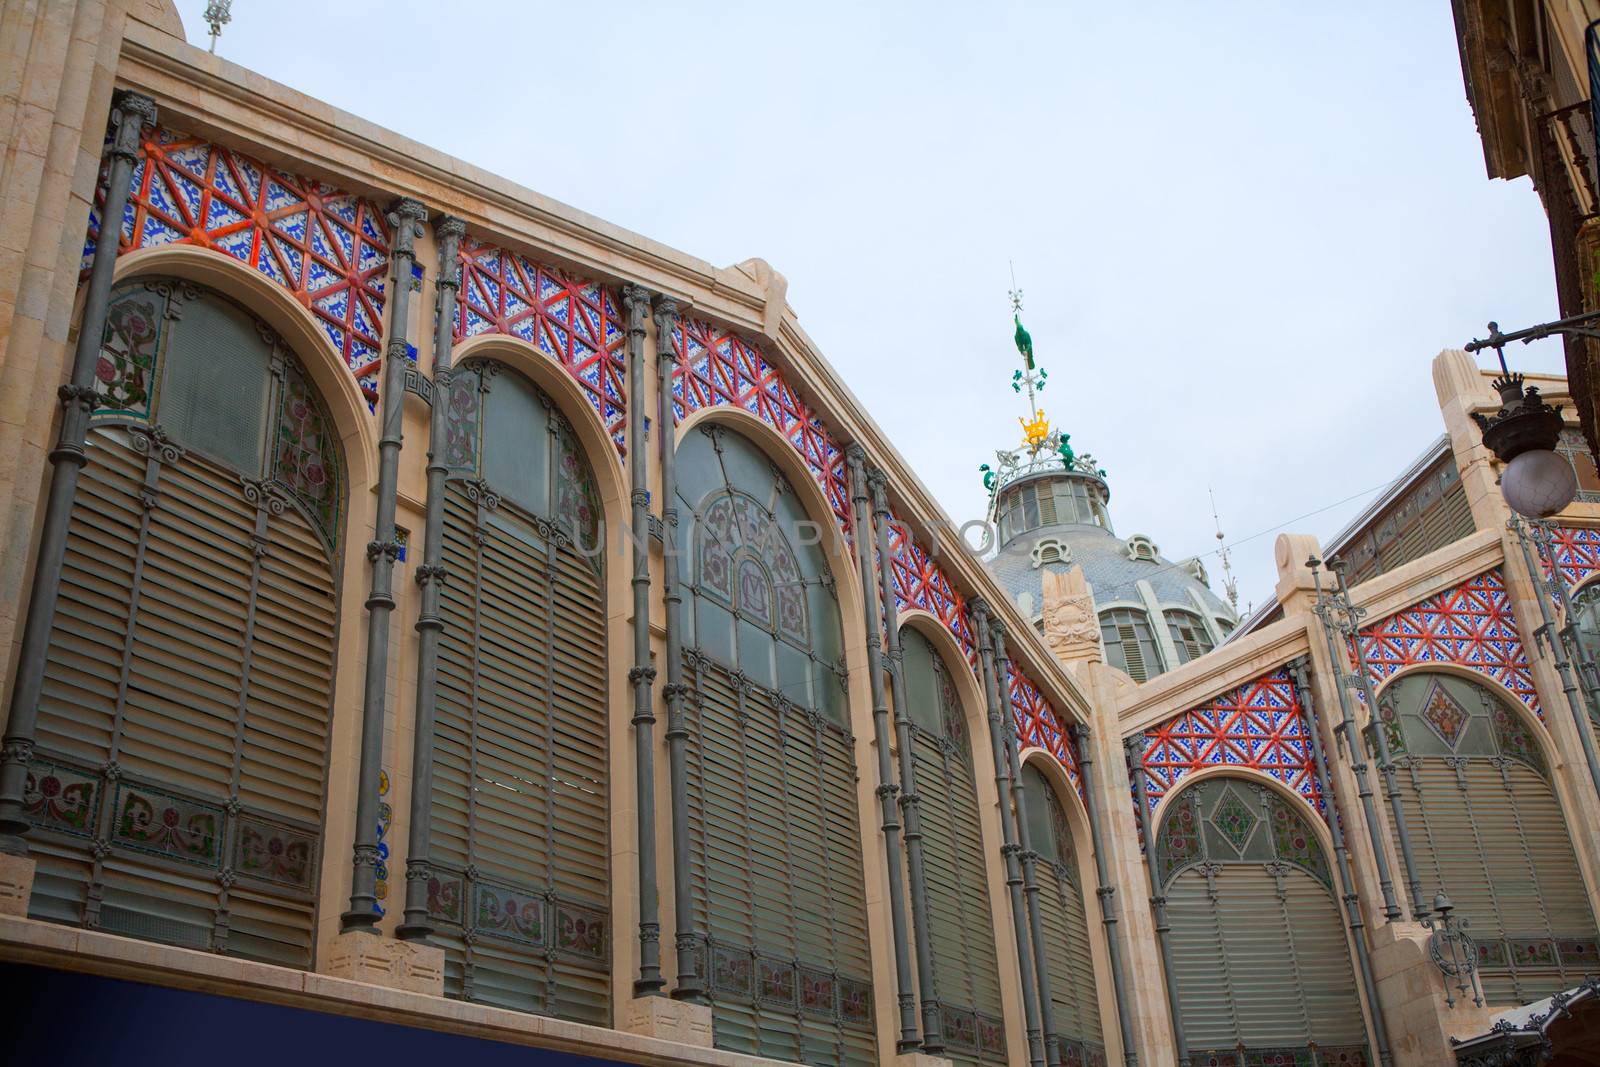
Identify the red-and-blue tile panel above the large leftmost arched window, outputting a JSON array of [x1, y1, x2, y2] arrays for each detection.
[[83, 128, 389, 406]]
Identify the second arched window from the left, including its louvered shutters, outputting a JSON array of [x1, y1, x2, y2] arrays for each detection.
[[427, 360, 611, 1025]]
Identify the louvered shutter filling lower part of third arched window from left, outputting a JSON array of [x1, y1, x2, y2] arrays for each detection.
[[686, 653, 877, 1065]]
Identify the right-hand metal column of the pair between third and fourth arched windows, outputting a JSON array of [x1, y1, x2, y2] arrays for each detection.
[[867, 469, 944, 1053]]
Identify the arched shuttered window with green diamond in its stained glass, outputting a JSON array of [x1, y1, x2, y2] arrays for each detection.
[[1155, 777, 1373, 1064]]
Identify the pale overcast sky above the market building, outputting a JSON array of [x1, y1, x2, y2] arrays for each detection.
[[178, 0, 1562, 609]]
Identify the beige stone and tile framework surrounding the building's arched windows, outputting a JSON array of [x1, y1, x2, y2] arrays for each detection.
[[0, 0, 1600, 1067]]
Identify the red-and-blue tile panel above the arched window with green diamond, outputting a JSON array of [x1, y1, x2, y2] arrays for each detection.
[[1144, 669, 1326, 817]]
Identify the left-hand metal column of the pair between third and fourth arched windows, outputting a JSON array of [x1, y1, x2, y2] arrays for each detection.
[[845, 445, 922, 1053]]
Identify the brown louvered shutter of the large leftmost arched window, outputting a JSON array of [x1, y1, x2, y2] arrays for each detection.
[[29, 427, 334, 966]]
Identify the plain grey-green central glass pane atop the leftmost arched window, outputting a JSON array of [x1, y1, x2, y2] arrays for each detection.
[[157, 298, 272, 477]]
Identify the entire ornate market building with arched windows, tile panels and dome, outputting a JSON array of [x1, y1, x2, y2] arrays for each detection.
[[0, 0, 1600, 1067]]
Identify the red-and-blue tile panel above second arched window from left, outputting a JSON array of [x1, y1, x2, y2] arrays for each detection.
[[454, 237, 627, 453]]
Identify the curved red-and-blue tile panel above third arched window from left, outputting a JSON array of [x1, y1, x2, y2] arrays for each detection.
[[672, 318, 851, 541]]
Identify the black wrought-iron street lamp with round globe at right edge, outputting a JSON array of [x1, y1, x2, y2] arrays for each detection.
[[1467, 312, 1600, 518]]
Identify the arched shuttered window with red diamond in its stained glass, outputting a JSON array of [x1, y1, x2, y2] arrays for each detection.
[[1378, 672, 1600, 1005]]
